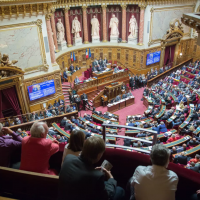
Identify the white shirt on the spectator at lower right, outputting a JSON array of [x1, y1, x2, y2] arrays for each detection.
[[131, 165, 178, 200]]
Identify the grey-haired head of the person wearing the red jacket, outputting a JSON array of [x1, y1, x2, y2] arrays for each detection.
[[30, 122, 49, 138]]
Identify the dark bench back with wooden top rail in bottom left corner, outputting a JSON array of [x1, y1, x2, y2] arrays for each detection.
[[0, 167, 58, 200]]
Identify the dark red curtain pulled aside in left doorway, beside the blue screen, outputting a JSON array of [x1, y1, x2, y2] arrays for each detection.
[[2, 87, 21, 115]]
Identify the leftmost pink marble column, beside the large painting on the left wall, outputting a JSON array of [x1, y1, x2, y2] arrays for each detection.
[[46, 14, 56, 64]]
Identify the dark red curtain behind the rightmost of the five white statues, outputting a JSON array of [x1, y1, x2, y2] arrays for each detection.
[[126, 5, 140, 42]]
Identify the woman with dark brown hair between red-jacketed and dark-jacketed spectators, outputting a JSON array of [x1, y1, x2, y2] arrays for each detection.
[[62, 130, 85, 163]]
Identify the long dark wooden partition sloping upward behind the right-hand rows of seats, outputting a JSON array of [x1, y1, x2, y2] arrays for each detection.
[[147, 58, 193, 87]]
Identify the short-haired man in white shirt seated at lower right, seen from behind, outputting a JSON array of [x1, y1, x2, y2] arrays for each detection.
[[130, 144, 178, 200]]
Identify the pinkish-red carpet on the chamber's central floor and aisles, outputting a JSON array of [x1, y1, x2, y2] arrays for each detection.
[[79, 88, 146, 145]]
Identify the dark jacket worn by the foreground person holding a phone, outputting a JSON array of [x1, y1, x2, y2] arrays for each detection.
[[58, 154, 117, 200]]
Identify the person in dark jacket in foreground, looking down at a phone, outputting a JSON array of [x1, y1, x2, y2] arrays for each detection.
[[58, 137, 125, 200]]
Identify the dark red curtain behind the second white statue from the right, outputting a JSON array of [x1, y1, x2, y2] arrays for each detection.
[[106, 5, 122, 41]]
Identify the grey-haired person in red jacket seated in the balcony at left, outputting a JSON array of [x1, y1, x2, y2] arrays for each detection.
[[20, 122, 59, 175]]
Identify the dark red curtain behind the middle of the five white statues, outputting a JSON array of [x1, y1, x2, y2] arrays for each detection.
[[87, 6, 103, 42]]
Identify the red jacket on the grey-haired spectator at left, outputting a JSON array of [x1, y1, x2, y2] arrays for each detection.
[[20, 136, 59, 174]]
